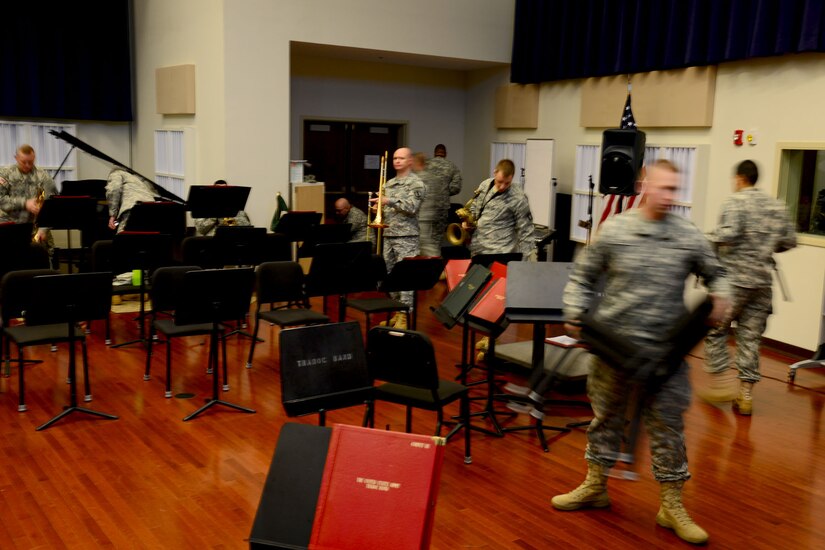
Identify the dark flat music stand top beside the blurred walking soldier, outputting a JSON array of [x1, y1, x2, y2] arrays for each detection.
[[505, 262, 574, 322]]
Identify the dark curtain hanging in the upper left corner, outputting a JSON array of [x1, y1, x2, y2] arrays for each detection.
[[0, 0, 133, 121]]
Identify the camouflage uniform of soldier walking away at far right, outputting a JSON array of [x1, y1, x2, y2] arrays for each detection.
[[705, 187, 796, 383]]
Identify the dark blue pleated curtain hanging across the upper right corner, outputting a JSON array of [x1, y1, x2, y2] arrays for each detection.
[[510, 0, 825, 84]]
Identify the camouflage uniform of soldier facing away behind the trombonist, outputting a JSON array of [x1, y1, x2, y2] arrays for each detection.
[[416, 157, 462, 256]]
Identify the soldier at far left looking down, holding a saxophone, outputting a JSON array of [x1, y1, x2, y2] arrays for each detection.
[[0, 145, 57, 256]]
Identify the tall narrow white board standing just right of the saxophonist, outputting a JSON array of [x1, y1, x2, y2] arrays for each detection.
[[524, 139, 556, 229]]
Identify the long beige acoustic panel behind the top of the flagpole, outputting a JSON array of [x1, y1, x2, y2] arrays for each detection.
[[581, 66, 716, 129]]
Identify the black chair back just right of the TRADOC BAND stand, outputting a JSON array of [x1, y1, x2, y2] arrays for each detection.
[[367, 327, 439, 390]]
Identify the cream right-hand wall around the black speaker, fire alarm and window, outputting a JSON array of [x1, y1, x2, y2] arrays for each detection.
[[486, 54, 825, 350]]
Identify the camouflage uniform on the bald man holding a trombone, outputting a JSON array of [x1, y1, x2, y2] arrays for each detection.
[[382, 172, 424, 308]]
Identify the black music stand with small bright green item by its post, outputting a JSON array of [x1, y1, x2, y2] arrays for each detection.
[[109, 233, 172, 348]]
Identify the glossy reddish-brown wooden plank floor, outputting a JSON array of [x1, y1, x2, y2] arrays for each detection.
[[0, 283, 825, 550]]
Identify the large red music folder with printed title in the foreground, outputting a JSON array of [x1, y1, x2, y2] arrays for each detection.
[[309, 424, 444, 550]]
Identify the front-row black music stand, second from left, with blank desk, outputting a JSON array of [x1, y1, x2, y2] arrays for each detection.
[[175, 267, 255, 422]]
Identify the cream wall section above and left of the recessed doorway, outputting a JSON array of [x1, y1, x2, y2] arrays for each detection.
[[224, 0, 514, 225]]
